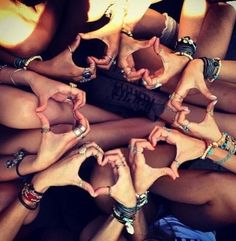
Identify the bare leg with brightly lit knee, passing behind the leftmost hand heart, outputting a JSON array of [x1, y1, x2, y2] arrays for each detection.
[[0, 86, 121, 129]]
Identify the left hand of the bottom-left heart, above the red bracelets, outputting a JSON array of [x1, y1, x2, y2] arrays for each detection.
[[32, 142, 103, 197]]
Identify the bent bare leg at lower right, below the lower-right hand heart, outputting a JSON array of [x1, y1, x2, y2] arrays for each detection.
[[152, 170, 236, 230]]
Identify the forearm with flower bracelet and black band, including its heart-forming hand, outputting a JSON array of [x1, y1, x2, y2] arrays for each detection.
[[0, 111, 90, 181]]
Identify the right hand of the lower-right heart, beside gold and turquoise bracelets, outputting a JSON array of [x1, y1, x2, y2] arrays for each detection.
[[148, 126, 206, 177]]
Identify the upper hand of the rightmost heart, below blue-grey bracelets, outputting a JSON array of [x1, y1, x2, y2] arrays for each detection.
[[168, 59, 217, 111]]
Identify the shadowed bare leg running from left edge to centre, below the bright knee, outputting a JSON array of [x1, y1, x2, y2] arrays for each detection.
[[0, 118, 163, 155]]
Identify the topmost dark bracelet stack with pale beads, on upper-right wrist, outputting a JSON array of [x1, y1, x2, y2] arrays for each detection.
[[175, 36, 197, 60]]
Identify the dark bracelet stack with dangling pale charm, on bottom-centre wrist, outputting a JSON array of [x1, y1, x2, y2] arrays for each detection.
[[112, 202, 137, 234]]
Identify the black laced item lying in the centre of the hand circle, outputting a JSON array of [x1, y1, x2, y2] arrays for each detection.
[[79, 66, 168, 121]]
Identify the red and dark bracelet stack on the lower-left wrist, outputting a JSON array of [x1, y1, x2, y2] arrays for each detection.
[[18, 183, 43, 210]]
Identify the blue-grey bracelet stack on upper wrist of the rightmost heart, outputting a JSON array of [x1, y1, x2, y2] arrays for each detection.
[[200, 57, 221, 83]]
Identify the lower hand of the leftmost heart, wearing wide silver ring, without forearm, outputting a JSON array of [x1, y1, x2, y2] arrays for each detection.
[[34, 110, 90, 171]]
